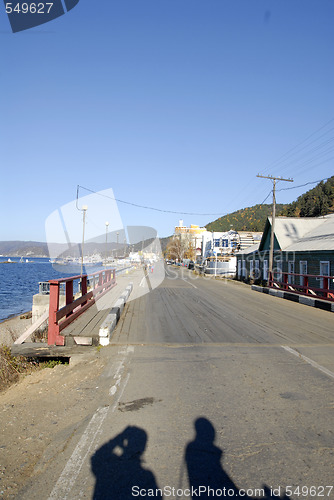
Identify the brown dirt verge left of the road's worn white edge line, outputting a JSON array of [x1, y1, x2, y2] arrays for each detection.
[[0, 348, 107, 499]]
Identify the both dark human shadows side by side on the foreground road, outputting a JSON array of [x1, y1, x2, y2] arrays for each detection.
[[91, 417, 289, 500]]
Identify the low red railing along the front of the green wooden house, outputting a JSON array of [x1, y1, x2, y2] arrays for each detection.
[[269, 271, 334, 301]]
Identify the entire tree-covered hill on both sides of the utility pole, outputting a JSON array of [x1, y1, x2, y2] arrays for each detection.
[[206, 176, 334, 231]]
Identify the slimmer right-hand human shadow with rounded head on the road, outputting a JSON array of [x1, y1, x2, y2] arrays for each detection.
[[185, 417, 289, 500]]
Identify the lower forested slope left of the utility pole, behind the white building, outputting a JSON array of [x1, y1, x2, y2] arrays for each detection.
[[206, 204, 284, 231]]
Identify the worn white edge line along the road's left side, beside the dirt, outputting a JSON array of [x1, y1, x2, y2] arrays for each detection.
[[49, 346, 134, 500]]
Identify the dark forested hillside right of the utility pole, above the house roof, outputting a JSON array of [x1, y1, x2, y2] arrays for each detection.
[[279, 175, 334, 217]]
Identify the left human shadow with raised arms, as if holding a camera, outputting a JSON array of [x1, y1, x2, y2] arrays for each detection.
[[91, 427, 158, 500]]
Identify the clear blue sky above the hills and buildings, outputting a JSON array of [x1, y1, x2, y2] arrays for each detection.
[[0, 0, 334, 241]]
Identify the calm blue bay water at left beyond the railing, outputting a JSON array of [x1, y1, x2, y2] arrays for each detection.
[[0, 257, 94, 321]]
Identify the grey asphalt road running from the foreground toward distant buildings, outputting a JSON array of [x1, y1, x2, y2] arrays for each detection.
[[20, 266, 334, 500]]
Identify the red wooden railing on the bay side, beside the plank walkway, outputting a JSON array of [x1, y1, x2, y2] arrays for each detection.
[[48, 269, 116, 345]]
